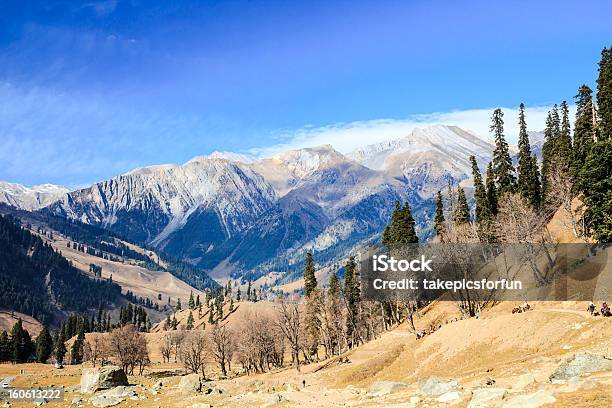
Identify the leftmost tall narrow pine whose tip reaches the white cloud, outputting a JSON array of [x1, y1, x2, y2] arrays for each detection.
[[490, 109, 515, 195]]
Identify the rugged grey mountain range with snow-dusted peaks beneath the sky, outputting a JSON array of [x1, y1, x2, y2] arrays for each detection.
[[0, 125, 541, 284]]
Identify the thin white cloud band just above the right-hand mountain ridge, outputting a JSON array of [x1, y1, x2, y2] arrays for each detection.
[[249, 106, 575, 157]]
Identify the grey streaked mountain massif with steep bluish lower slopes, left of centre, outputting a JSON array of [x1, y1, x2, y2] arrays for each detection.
[[51, 157, 276, 259]]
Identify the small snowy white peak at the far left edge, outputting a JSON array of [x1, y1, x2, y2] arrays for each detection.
[[0, 181, 69, 211]]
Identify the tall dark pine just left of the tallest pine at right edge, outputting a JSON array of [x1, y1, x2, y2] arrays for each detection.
[[572, 85, 596, 182]]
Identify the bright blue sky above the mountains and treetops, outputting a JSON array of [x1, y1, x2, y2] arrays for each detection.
[[0, 0, 612, 187]]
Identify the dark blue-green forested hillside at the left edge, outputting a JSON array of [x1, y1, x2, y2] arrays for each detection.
[[0, 215, 121, 323]]
